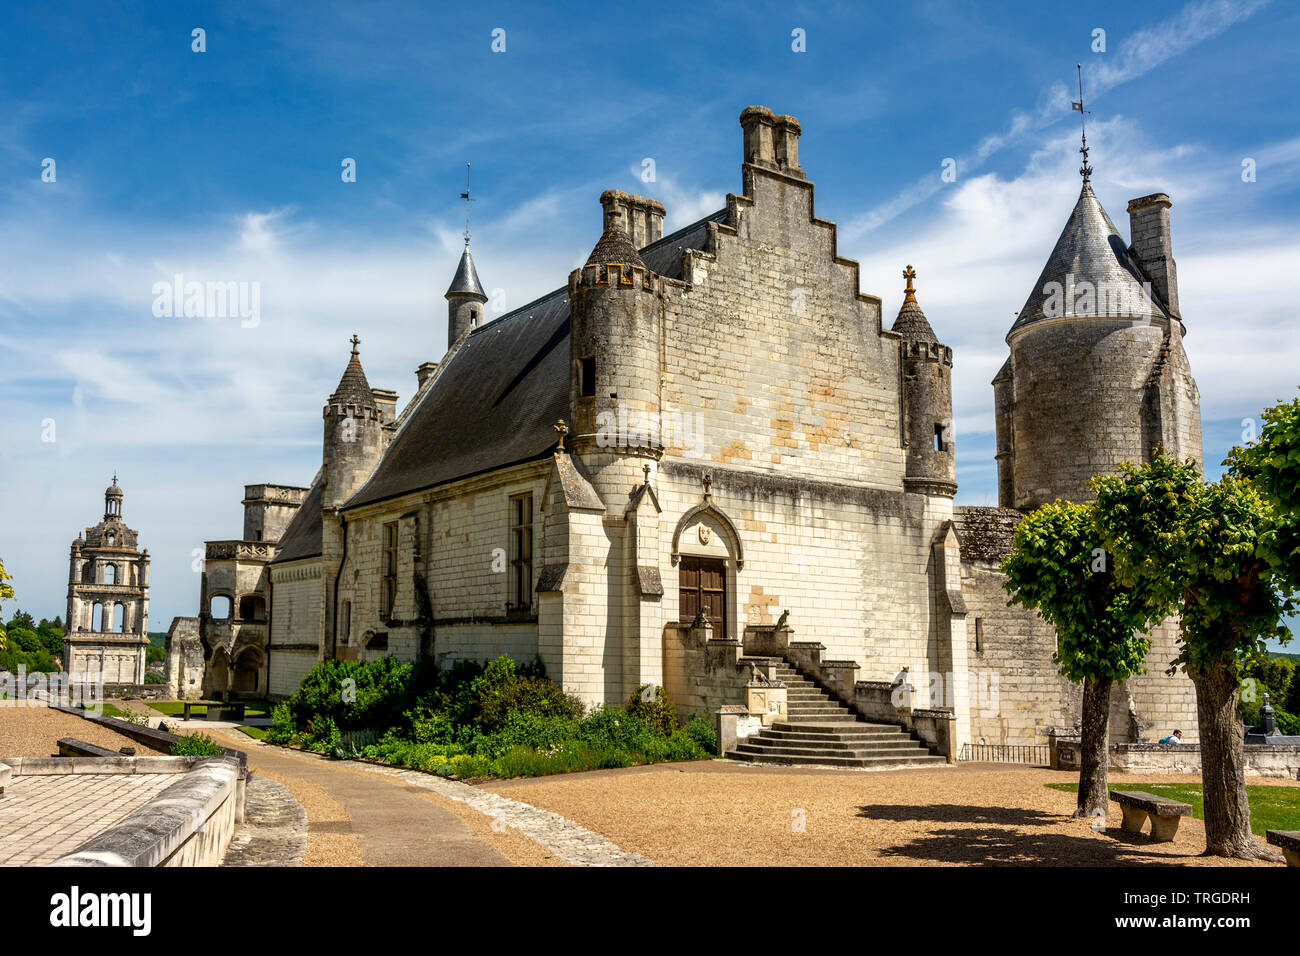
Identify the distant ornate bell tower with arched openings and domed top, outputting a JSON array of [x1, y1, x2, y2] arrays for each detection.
[[62, 475, 150, 684]]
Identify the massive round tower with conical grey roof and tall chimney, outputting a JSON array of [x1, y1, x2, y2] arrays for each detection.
[[993, 178, 1201, 510]]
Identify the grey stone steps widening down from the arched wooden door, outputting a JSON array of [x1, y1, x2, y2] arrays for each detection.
[[727, 662, 946, 769]]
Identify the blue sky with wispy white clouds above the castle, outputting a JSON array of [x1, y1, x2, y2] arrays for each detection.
[[0, 1, 1300, 642]]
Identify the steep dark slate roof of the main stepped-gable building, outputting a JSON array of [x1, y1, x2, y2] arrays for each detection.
[[345, 209, 727, 510]]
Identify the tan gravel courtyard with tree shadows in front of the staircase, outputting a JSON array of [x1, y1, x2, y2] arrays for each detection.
[[482, 761, 1300, 866]]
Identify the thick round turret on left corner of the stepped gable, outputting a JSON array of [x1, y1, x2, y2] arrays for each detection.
[[569, 209, 663, 488]]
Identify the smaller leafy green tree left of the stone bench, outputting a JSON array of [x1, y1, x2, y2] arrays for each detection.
[[1002, 501, 1162, 817]]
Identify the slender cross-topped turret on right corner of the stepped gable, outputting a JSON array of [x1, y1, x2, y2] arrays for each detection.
[[893, 265, 957, 498]]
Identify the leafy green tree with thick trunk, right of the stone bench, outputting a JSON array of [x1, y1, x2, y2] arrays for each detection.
[[1092, 454, 1290, 860]]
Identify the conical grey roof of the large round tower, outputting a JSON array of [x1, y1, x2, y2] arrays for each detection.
[[1011, 182, 1169, 332]]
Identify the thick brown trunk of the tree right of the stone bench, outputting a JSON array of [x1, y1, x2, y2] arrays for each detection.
[[1190, 663, 1282, 862]]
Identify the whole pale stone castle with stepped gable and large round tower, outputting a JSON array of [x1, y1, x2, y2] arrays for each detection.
[[170, 107, 1200, 745]]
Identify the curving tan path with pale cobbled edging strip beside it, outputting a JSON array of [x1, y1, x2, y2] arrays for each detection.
[[215, 731, 654, 866]]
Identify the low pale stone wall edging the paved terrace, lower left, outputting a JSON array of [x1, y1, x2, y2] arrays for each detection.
[[43, 757, 243, 866]]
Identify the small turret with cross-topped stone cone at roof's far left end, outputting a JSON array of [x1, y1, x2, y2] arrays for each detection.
[[321, 336, 384, 507]]
